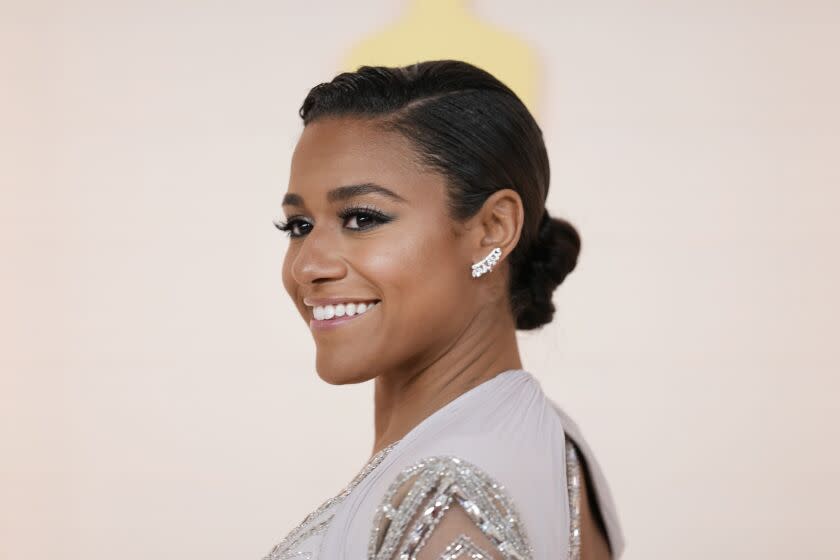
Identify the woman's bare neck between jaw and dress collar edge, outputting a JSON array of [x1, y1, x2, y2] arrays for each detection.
[[372, 304, 522, 455]]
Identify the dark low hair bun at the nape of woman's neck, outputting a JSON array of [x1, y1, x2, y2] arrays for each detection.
[[511, 210, 581, 330]]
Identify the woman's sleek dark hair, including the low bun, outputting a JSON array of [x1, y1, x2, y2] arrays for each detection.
[[300, 60, 580, 330]]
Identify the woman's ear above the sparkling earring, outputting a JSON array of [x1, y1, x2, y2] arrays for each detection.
[[470, 189, 525, 262]]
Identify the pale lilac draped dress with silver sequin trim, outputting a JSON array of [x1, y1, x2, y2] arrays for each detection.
[[264, 369, 625, 560]]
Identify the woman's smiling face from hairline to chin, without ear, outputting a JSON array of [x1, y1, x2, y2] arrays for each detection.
[[283, 117, 477, 384]]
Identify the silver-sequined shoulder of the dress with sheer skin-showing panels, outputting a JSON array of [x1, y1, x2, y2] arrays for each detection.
[[368, 455, 533, 560]]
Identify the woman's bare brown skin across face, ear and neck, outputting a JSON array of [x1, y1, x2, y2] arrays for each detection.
[[283, 117, 606, 560]]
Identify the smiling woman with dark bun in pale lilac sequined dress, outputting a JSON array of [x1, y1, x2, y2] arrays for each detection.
[[266, 60, 624, 560]]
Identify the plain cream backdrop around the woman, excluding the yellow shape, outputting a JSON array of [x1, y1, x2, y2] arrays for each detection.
[[0, 0, 840, 560]]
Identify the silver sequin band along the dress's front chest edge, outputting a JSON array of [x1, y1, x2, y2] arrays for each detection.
[[263, 441, 399, 560]]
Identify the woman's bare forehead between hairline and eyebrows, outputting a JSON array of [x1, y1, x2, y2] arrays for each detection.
[[288, 117, 445, 206]]
